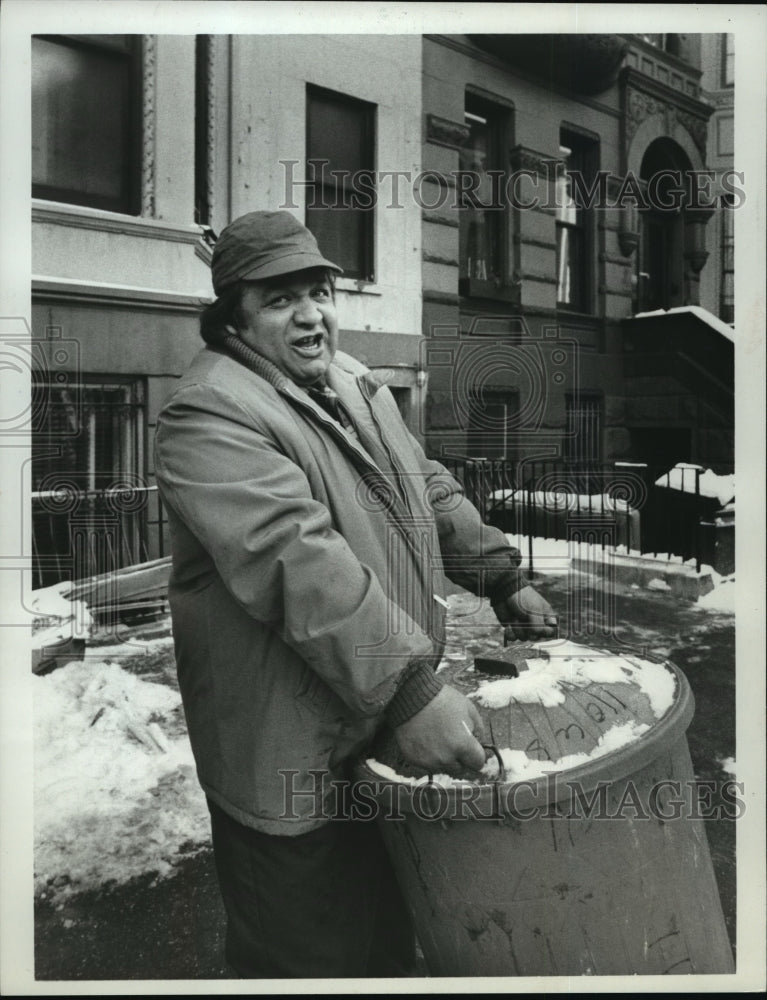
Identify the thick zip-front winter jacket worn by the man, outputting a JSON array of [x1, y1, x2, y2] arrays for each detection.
[[155, 347, 519, 834]]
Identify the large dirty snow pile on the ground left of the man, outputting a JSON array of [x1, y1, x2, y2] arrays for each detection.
[[34, 661, 210, 898]]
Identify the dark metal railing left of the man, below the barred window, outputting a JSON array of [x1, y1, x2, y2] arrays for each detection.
[[31, 485, 167, 588]]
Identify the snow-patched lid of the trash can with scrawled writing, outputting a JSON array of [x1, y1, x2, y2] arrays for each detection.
[[367, 639, 684, 785]]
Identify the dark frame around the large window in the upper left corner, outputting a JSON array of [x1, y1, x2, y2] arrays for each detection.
[[30, 34, 142, 216]]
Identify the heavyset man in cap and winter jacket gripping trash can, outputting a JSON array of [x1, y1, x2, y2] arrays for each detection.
[[156, 212, 556, 978]]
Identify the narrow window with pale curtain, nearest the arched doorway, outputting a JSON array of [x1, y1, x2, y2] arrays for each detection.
[[556, 129, 597, 312]]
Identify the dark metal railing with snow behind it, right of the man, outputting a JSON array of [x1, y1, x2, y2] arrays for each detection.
[[443, 457, 720, 571]]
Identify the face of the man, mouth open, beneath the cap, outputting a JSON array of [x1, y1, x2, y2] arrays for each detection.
[[239, 268, 338, 385]]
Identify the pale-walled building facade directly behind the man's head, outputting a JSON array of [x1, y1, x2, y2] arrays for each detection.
[[31, 35, 425, 586]]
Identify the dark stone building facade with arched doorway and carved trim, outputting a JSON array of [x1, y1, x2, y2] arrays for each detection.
[[423, 35, 733, 471]]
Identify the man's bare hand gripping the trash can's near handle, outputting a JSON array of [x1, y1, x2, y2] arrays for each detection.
[[394, 685, 485, 774]]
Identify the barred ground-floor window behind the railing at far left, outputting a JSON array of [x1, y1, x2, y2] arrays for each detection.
[[31, 376, 148, 587]]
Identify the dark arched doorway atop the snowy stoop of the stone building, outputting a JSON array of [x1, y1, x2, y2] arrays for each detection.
[[637, 137, 692, 312]]
